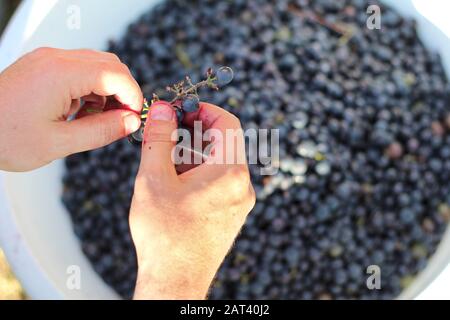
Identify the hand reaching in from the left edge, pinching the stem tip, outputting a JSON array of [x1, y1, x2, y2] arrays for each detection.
[[0, 48, 143, 171]]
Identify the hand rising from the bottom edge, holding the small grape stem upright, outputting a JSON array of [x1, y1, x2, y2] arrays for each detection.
[[130, 102, 255, 299]]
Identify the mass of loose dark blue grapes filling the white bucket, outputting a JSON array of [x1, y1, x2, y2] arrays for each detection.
[[63, 0, 450, 299]]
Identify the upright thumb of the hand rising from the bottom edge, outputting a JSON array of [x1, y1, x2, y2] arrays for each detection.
[[139, 101, 177, 177]]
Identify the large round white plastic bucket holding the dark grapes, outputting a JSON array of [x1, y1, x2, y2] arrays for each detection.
[[0, 0, 450, 299]]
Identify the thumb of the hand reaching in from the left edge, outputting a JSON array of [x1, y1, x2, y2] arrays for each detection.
[[62, 109, 141, 154]]
